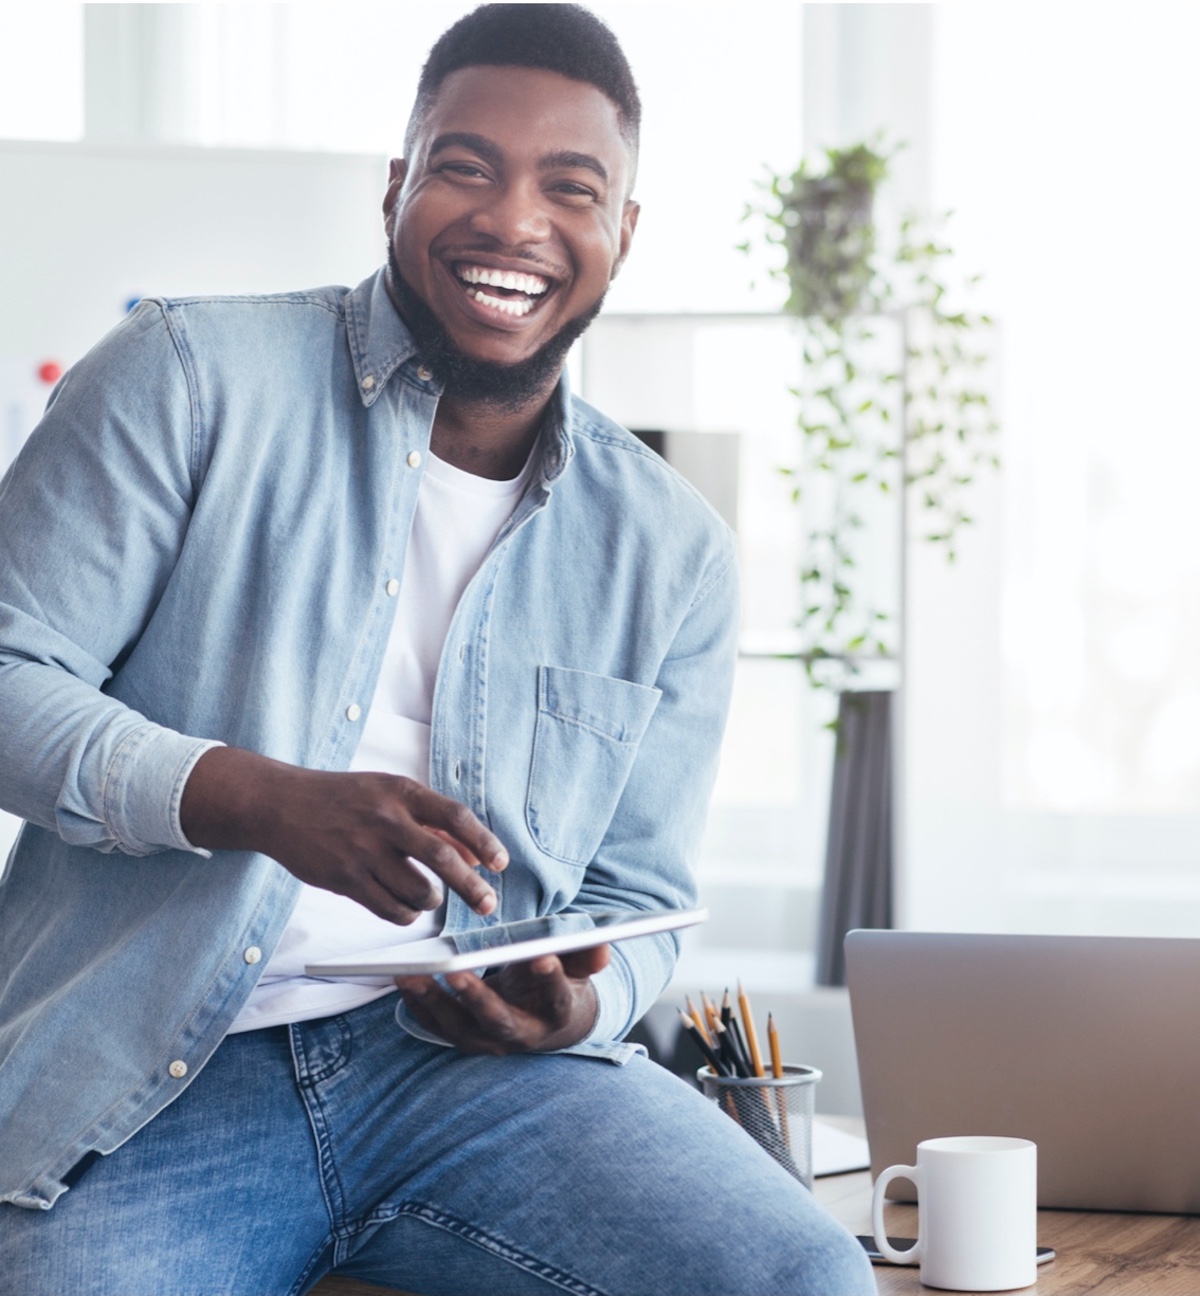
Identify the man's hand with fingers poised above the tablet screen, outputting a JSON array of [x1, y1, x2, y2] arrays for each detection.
[[179, 746, 508, 925]]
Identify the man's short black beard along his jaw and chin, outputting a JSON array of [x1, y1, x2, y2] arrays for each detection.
[[387, 241, 604, 413]]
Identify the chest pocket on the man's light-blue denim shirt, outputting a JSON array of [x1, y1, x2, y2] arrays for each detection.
[[525, 666, 662, 864]]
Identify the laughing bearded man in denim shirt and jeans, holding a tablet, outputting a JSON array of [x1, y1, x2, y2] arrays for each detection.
[[0, 5, 872, 1296]]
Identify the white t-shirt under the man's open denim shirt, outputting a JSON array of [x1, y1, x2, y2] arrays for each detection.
[[229, 454, 538, 1034]]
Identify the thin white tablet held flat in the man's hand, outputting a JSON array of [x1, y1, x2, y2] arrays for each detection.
[[305, 908, 709, 977]]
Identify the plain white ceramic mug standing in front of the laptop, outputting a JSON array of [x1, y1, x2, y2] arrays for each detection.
[[871, 1137, 1038, 1292]]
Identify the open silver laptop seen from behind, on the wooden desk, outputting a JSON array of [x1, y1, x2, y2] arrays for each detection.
[[846, 931, 1200, 1214]]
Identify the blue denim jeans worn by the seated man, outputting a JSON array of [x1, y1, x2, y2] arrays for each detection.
[[0, 995, 875, 1296]]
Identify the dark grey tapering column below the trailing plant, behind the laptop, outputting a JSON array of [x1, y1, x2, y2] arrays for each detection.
[[816, 692, 892, 985]]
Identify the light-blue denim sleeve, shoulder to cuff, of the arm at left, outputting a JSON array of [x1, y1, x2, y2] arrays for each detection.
[[0, 302, 216, 855]]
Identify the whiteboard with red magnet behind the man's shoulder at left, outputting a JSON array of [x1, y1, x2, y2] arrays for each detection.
[[0, 143, 387, 470]]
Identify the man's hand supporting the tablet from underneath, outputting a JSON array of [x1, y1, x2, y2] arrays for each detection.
[[395, 945, 609, 1054]]
